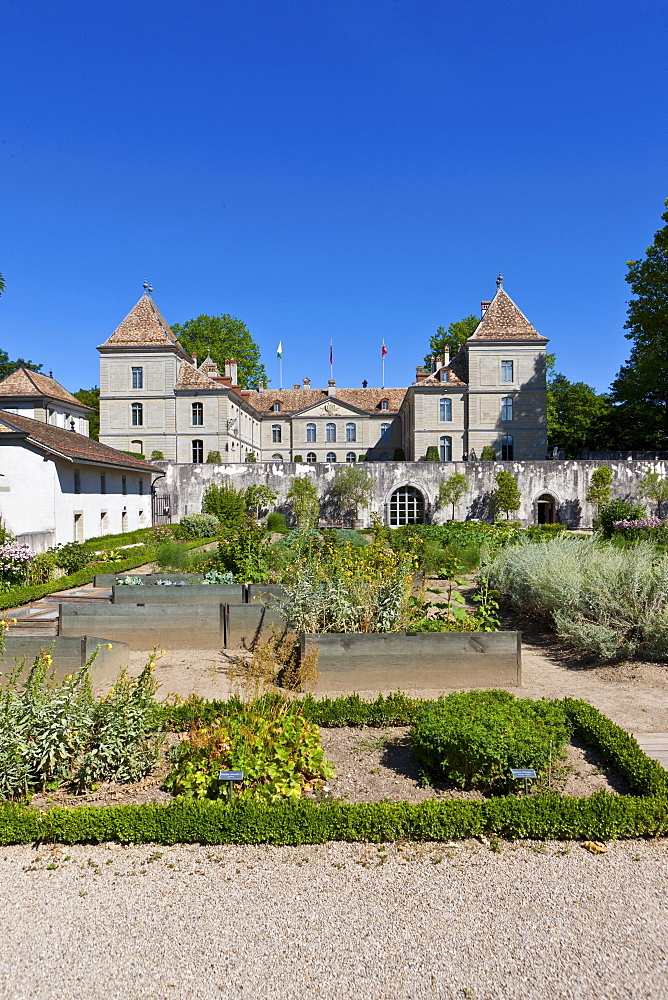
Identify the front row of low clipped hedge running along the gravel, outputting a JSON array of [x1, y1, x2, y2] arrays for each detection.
[[0, 792, 668, 845]]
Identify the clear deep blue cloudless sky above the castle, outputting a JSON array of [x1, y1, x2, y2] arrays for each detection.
[[0, 0, 668, 390]]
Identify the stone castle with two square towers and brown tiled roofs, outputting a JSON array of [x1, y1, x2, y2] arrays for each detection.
[[98, 280, 547, 464]]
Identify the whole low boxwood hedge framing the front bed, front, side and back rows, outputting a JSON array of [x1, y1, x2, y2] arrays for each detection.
[[0, 693, 668, 844]]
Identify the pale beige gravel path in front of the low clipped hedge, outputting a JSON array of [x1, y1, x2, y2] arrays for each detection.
[[0, 839, 668, 1000]]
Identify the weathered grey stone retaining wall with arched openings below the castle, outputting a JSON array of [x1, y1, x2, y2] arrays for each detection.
[[155, 461, 668, 528]]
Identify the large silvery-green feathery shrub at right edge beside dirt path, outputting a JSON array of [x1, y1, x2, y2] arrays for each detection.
[[491, 535, 668, 660]]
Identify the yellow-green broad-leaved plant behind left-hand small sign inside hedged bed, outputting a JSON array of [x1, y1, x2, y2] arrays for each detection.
[[166, 699, 334, 802]]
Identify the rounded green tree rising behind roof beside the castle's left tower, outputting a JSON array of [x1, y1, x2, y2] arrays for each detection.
[[172, 313, 267, 389]]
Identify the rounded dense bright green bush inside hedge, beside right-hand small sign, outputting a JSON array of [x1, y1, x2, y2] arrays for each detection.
[[410, 691, 571, 792]]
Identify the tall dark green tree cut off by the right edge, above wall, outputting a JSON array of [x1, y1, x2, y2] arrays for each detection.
[[612, 199, 668, 448]]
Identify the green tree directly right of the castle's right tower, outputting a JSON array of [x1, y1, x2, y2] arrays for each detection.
[[547, 354, 612, 458]]
